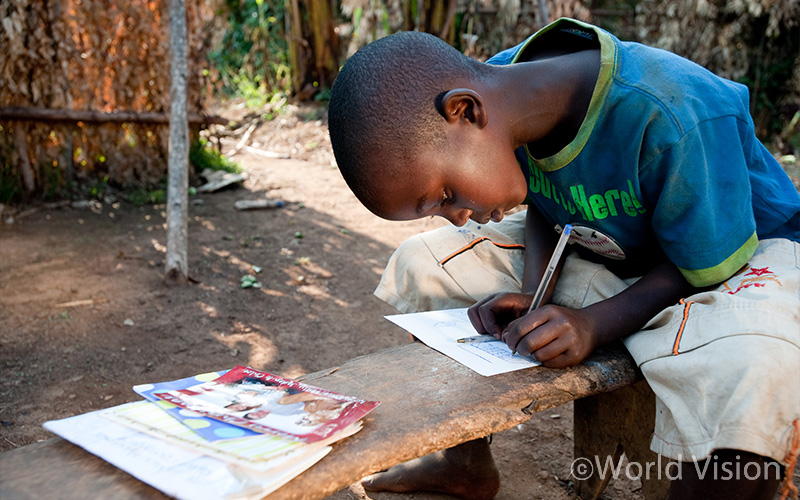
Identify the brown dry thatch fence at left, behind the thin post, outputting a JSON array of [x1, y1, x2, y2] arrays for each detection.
[[0, 0, 219, 202]]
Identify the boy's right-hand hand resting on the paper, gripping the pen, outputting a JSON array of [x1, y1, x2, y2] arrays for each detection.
[[501, 305, 598, 368]]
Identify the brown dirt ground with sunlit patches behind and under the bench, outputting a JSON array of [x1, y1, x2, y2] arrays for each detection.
[[0, 103, 796, 500]]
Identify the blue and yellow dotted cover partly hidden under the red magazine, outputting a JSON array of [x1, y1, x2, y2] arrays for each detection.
[[133, 370, 259, 441]]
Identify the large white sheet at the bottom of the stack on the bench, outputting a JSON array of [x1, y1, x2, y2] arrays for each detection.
[[44, 404, 331, 500]]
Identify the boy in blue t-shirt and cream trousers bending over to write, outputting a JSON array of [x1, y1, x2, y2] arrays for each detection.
[[329, 19, 800, 499]]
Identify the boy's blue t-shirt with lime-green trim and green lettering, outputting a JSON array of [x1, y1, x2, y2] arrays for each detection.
[[488, 19, 800, 287]]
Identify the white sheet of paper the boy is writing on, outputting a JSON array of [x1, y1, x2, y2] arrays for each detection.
[[386, 308, 541, 376]]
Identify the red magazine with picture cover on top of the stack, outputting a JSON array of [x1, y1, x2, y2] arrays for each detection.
[[153, 365, 380, 443]]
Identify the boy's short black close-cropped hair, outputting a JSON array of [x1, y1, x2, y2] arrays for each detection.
[[328, 31, 483, 212]]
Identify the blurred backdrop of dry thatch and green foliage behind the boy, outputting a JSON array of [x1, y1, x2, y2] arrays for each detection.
[[0, 0, 800, 203]]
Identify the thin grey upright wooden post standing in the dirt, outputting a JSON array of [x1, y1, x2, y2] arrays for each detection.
[[164, 0, 189, 285]]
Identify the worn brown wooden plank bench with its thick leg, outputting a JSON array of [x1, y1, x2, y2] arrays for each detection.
[[0, 342, 667, 500]]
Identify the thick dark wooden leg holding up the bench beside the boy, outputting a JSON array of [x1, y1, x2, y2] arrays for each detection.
[[573, 381, 669, 500]]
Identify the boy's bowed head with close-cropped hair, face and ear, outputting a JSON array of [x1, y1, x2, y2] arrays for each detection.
[[328, 32, 525, 225]]
